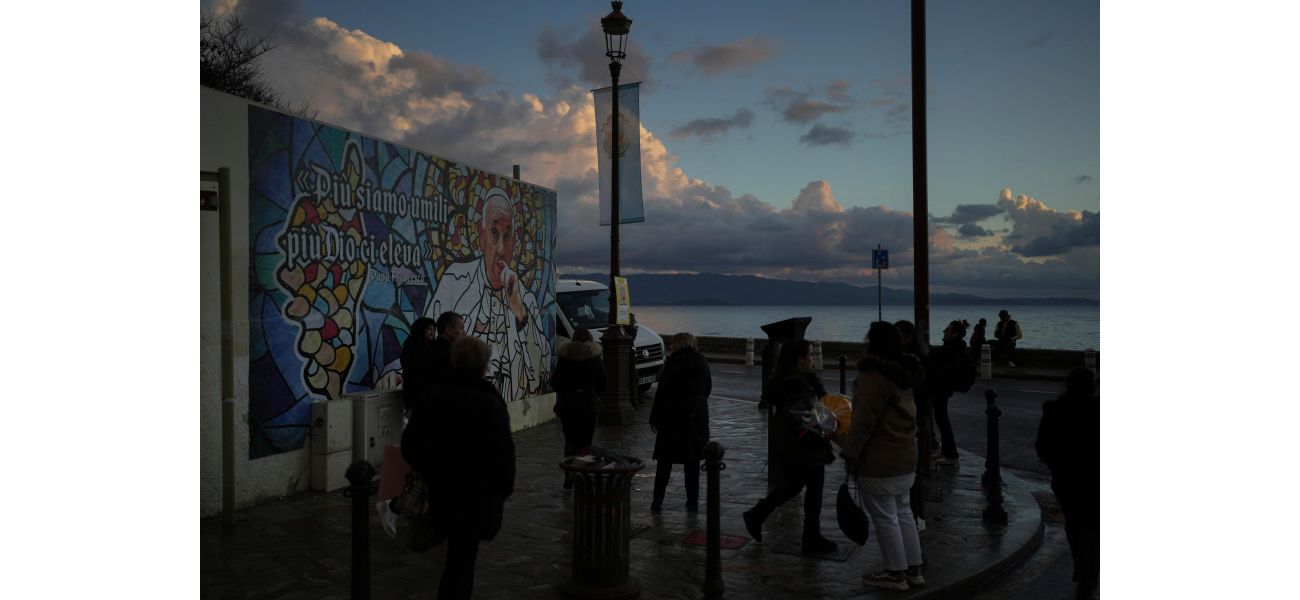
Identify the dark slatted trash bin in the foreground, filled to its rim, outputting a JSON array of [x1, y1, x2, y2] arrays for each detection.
[[560, 456, 645, 600]]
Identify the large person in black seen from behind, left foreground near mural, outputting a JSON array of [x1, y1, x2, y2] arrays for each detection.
[[402, 335, 515, 600]]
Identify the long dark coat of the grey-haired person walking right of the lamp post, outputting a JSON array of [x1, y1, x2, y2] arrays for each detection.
[[650, 348, 714, 464]]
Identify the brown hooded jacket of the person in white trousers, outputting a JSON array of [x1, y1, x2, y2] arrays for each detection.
[[840, 355, 920, 477]]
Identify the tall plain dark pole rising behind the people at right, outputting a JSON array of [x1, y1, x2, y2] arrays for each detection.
[[911, 0, 930, 344]]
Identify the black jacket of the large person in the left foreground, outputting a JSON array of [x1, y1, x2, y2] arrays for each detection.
[[402, 373, 515, 540]]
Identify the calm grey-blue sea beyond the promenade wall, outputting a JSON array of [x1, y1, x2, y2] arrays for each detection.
[[632, 304, 1101, 352]]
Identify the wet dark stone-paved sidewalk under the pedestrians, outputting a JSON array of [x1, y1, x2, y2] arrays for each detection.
[[200, 399, 1043, 600]]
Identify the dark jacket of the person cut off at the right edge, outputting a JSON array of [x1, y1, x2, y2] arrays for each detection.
[[1034, 395, 1101, 487]]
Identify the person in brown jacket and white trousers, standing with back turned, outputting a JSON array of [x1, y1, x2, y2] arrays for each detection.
[[840, 321, 926, 591]]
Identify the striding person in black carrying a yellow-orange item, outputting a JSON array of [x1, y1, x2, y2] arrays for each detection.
[[742, 339, 836, 555]]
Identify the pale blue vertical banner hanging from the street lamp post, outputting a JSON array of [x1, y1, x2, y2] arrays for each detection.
[[592, 83, 646, 225]]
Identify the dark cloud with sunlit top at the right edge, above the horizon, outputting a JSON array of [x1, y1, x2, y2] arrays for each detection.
[[997, 188, 1101, 257]]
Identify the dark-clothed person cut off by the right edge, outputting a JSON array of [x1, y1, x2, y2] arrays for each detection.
[[1034, 368, 1101, 599]]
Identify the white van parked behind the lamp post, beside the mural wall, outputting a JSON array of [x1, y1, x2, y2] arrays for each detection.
[[555, 279, 664, 392]]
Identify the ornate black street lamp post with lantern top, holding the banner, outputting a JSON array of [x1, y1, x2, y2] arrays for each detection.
[[599, 1, 636, 425]]
